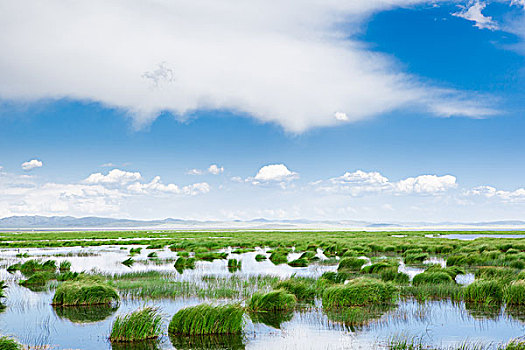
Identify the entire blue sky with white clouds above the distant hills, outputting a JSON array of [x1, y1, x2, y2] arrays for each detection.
[[0, 0, 525, 222]]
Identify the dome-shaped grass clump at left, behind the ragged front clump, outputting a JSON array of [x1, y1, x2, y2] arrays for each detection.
[[53, 278, 119, 306]]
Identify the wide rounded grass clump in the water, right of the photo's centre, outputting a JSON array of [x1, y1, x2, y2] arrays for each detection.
[[323, 278, 398, 308]]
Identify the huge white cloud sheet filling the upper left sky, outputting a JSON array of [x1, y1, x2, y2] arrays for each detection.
[[0, 0, 494, 132]]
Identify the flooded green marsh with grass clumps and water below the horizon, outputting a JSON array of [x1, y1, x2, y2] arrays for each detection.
[[0, 231, 525, 350]]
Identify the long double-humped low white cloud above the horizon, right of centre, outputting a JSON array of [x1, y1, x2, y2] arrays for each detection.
[[318, 170, 457, 196]]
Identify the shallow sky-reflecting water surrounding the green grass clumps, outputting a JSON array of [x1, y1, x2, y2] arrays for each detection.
[[0, 246, 525, 350]]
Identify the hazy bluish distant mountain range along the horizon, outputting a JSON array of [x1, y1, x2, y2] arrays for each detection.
[[0, 216, 525, 231]]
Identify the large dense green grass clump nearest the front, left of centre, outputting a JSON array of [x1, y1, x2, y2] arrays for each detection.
[[168, 304, 244, 335]]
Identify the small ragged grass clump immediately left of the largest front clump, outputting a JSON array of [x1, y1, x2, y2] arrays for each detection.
[[109, 307, 162, 343]]
